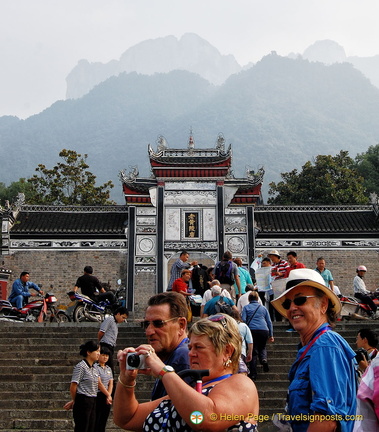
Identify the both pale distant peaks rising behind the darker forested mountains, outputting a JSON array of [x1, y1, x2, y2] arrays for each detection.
[[66, 33, 379, 99]]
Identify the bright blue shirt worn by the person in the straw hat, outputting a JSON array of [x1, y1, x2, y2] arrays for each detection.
[[288, 324, 357, 432]]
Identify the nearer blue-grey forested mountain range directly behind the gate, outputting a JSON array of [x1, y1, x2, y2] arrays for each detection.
[[0, 33, 379, 203]]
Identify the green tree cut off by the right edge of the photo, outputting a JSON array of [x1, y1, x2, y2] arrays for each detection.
[[355, 144, 379, 195]]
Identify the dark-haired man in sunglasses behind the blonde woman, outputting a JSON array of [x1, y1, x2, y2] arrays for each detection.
[[142, 291, 189, 400]]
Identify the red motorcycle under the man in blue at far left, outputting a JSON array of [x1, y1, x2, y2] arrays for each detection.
[[0, 293, 71, 322]]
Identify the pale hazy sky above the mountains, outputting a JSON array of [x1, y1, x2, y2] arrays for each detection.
[[0, 0, 379, 118]]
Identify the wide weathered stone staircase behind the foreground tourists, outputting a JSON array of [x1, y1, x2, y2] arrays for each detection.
[[0, 322, 378, 432]]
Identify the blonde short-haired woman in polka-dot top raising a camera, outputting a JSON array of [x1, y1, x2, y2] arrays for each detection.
[[113, 314, 259, 432]]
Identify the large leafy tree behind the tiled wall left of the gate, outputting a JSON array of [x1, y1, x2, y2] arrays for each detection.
[[28, 149, 114, 205]]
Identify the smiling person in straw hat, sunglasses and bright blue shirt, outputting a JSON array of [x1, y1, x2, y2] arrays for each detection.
[[271, 269, 356, 432]]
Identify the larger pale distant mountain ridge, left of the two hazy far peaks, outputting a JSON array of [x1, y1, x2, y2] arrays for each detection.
[[66, 33, 241, 99]]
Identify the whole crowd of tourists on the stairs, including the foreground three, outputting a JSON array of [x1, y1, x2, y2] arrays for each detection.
[[8, 250, 379, 432]]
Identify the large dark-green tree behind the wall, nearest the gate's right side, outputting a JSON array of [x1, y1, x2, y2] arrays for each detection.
[[268, 150, 368, 205]]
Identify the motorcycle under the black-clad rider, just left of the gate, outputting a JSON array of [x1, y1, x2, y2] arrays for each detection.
[[67, 281, 126, 322]]
